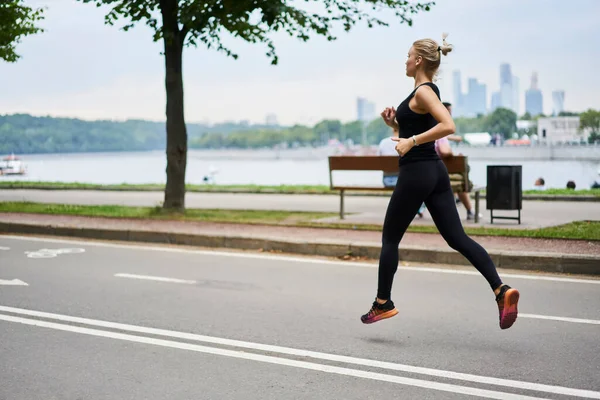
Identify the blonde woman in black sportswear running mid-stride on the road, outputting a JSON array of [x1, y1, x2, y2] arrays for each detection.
[[361, 35, 519, 329]]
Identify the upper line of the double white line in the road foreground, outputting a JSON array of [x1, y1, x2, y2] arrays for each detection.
[[0, 306, 600, 399]]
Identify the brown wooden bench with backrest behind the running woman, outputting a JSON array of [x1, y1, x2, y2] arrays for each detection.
[[329, 156, 483, 223]]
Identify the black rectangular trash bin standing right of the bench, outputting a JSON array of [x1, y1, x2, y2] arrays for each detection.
[[485, 165, 523, 224]]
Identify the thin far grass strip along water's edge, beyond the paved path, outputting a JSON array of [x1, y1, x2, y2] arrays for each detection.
[[0, 181, 600, 197]]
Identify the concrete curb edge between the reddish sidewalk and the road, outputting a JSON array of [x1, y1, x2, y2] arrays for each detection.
[[0, 222, 600, 275]]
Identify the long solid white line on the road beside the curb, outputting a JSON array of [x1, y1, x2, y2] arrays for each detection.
[[0, 235, 600, 285]]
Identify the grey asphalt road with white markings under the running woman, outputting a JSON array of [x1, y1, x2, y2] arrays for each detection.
[[0, 236, 600, 400]]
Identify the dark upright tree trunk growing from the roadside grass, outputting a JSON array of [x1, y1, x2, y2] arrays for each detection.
[[160, 0, 187, 211]]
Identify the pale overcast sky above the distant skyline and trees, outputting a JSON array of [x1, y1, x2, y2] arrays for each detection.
[[0, 0, 600, 124]]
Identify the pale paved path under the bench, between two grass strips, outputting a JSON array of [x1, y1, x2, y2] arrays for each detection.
[[0, 190, 600, 228]]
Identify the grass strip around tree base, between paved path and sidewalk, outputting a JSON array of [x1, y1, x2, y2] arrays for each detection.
[[0, 202, 600, 240]]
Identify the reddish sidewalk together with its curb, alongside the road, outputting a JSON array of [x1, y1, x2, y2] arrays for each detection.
[[0, 213, 600, 275]]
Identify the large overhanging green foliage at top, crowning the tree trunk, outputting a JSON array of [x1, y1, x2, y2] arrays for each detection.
[[79, 0, 435, 64]]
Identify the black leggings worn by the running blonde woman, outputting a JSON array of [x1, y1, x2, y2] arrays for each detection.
[[377, 160, 502, 300]]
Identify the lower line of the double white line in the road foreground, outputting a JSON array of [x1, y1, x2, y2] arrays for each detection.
[[0, 314, 552, 400]]
